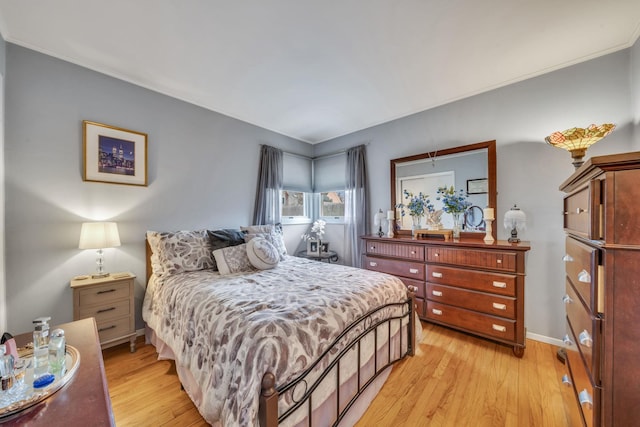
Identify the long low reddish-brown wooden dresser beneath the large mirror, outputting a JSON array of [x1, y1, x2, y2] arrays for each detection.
[[362, 236, 530, 357]]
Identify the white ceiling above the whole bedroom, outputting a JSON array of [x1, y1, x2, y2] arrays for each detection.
[[0, 0, 640, 143]]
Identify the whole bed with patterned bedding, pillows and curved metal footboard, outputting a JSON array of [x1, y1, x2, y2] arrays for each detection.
[[143, 226, 420, 427]]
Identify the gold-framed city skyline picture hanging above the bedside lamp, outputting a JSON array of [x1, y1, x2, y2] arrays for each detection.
[[82, 120, 147, 186]]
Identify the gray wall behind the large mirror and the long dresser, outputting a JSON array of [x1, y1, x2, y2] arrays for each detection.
[[314, 43, 637, 338]]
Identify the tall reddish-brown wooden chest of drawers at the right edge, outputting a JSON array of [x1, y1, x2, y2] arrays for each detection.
[[560, 152, 640, 427]]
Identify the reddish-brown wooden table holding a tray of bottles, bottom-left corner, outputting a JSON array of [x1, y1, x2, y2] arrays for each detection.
[[2, 317, 115, 427]]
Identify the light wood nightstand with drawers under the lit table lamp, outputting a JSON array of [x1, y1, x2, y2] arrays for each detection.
[[71, 273, 136, 353]]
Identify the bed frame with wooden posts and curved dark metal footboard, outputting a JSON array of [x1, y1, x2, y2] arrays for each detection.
[[145, 239, 416, 427]]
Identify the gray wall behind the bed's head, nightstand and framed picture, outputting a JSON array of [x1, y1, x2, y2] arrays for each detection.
[[5, 44, 311, 332]]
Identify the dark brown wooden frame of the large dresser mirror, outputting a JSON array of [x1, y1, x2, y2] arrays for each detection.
[[390, 140, 498, 240]]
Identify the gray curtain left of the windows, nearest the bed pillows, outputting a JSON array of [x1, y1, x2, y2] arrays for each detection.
[[253, 145, 282, 225]]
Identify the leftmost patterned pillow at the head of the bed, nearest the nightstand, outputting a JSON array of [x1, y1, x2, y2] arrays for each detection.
[[147, 230, 213, 276]]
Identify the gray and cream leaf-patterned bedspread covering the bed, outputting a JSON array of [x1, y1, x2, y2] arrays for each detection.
[[143, 256, 406, 426]]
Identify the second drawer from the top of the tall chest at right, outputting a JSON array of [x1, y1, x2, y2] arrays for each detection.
[[564, 237, 604, 313]]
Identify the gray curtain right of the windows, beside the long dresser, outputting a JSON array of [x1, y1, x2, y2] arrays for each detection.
[[344, 145, 369, 267]]
